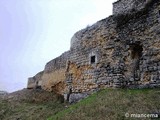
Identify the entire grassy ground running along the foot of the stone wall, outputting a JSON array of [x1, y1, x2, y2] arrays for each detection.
[[0, 89, 160, 120]]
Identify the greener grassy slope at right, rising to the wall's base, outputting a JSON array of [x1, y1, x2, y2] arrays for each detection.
[[48, 89, 160, 120]]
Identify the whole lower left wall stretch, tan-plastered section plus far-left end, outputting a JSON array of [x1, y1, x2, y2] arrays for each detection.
[[27, 51, 69, 94]]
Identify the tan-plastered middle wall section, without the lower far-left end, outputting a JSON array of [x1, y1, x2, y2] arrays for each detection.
[[42, 52, 69, 93]]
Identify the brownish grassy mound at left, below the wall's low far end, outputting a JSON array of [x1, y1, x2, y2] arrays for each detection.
[[0, 89, 66, 120]]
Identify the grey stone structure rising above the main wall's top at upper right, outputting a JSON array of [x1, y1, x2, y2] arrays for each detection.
[[113, 0, 150, 14]]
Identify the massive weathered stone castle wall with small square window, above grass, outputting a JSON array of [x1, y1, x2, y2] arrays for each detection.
[[27, 0, 160, 102]]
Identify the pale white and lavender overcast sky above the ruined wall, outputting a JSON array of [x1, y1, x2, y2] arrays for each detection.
[[0, 0, 116, 92]]
